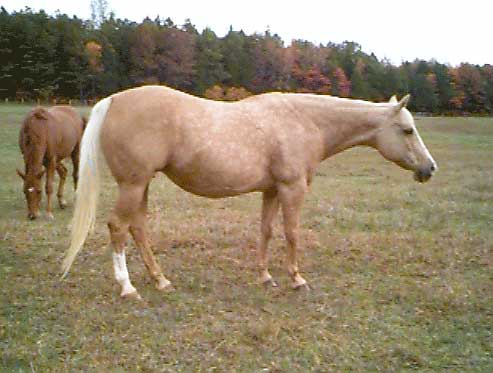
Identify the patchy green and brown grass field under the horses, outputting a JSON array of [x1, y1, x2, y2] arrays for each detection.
[[0, 105, 493, 372]]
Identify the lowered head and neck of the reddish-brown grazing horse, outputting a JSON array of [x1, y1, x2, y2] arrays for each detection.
[[17, 108, 48, 220]]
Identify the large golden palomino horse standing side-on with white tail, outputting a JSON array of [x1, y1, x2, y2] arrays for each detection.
[[63, 86, 437, 297]]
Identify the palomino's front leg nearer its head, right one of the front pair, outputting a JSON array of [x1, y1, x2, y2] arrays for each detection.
[[279, 180, 307, 289]]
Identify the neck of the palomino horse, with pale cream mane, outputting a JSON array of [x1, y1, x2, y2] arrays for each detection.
[[286, 95, 386, 159]]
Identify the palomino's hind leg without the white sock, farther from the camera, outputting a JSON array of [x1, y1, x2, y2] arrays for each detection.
[[130, 184, 171, 290]]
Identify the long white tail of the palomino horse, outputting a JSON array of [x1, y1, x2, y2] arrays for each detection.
[[62, 97, 111, 278]]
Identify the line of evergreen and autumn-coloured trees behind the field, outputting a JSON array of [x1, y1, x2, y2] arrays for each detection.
[[0, 7, 493, 114]]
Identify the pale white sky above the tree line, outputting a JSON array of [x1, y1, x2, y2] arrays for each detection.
[[0, 0, 493, 65]]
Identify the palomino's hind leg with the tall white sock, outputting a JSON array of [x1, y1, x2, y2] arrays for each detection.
[[108, 184, 145, 299]]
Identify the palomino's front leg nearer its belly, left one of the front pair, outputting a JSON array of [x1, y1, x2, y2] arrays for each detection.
[[257, 190, 279, 286]]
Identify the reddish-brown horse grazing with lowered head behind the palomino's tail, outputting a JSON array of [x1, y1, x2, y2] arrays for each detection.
[[17, 106, 86, 219]]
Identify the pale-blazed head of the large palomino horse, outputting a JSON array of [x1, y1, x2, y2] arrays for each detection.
[[374, 95, 438, 183]]
